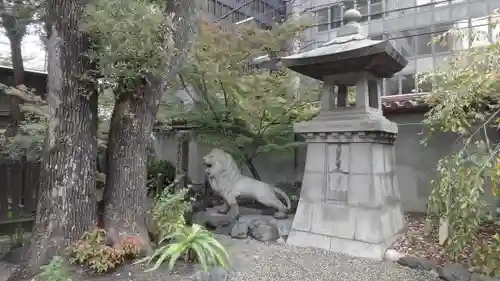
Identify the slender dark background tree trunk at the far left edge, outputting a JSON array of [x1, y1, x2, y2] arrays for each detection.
[[5, 23, 24, 137]]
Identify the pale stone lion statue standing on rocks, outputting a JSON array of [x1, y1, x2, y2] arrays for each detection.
[[203, 148, 291, 219]]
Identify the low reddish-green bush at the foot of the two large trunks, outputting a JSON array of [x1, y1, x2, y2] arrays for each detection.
[[68, 229, 140, 273]]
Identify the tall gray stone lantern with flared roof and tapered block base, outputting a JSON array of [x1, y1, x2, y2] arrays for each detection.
[[282, 10, 408, 259]]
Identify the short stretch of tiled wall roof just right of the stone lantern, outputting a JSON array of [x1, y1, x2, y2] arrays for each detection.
[[381, 93, 428, 112]]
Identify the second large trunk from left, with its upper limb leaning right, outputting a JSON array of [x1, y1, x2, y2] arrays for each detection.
[[103, 0, 197, 249]]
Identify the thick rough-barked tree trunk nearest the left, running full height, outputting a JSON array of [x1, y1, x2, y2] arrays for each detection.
[[8, 0, 97, 281]]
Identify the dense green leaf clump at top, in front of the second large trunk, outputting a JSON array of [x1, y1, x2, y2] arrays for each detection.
[[84, 0, 174, 87]]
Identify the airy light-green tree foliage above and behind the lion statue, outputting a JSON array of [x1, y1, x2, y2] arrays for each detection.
[[169, 20, 318, 166]]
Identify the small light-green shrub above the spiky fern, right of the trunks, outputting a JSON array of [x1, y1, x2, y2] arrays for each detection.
[[150, 189, 191, 237]]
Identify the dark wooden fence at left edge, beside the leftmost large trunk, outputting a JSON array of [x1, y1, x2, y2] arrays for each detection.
[[0, 160, 40, 229]]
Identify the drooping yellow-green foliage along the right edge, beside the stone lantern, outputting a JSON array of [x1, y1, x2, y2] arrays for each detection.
[[420, 12, 500, 274]]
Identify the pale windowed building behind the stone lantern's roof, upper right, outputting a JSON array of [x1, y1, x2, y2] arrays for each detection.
[[293, 0, 500, 95]]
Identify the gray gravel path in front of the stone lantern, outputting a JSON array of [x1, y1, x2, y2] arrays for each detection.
[[221, 234, 440, 281]]
